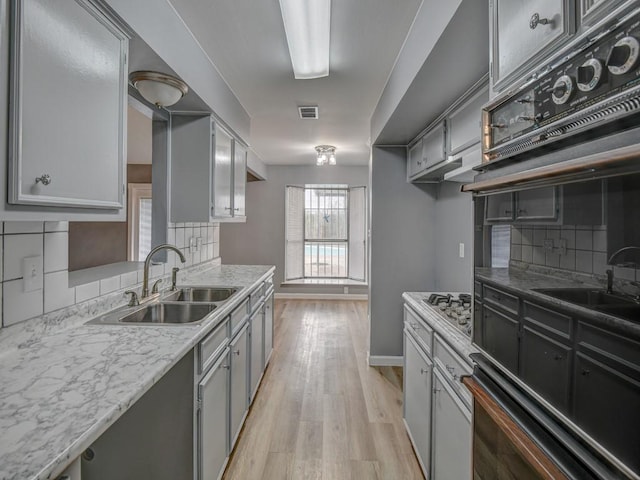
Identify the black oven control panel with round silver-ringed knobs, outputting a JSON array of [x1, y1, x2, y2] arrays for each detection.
[[483, 12, 640, 162]]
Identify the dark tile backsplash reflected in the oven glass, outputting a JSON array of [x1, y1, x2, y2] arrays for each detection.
[[511, 225, 640, 280]]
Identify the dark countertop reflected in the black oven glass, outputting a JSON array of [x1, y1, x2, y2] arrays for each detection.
[[475, 268, 640, 339]]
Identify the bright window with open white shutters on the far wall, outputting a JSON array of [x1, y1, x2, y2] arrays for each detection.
[[285, 185, 367, 281]]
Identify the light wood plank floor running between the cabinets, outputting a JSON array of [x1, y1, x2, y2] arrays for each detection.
[[223, 300, 424, 480]]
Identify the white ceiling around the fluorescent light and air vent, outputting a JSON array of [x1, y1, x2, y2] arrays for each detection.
[[170, 0, 421, 165]]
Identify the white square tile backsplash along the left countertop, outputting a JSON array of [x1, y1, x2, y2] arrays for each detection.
[[0, 222, 220, 327]]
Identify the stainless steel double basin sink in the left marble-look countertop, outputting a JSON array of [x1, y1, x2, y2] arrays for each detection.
[[87, 287, 239, 325]]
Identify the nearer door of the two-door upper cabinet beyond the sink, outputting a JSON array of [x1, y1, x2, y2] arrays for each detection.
[[211, 124, 233, 218]]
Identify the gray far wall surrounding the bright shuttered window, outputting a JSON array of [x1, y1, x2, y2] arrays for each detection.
[[220, 165, 368, 293]]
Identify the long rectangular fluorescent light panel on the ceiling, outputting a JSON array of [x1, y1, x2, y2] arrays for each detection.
[[280, 0, 331, 79]]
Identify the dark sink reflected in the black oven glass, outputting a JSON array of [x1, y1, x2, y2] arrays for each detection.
[[534, 288, 640, 321]]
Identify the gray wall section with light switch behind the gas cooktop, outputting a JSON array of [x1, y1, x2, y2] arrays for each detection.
[[433, 182, 473, 292]]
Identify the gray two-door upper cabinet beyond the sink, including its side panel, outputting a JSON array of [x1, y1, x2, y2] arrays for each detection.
[[171, 114, 247, 222]]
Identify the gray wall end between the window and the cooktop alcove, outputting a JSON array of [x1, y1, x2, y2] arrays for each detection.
[[369, 147, 439, 356]]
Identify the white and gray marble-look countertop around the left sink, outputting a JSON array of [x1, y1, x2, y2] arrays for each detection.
[[0, 265, 274, 480]]
